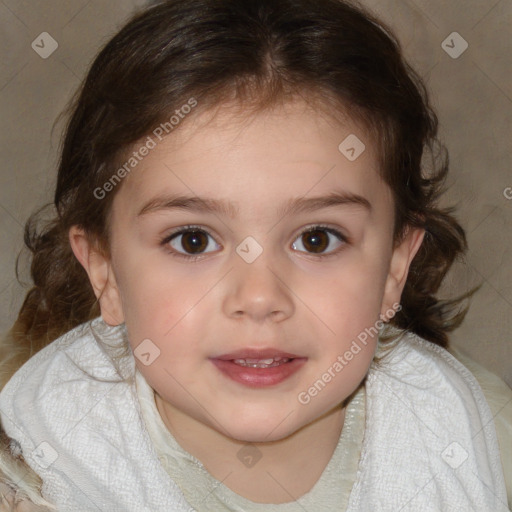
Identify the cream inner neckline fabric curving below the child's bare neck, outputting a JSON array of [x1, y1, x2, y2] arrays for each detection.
[[136, 371, 365, 512]]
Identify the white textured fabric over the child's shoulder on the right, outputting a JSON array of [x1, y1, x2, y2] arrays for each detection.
[[357, 332, 506, 511]]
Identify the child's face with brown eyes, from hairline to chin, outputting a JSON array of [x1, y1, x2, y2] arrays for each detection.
[[80, 102, 421, 442]]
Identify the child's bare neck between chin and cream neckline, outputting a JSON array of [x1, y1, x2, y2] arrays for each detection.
[[155, 393, 345, 504]]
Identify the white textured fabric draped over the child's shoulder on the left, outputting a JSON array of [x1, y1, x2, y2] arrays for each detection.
[[0, 317, 192, 512]]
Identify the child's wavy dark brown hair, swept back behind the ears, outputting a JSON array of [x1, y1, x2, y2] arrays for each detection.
[[3, 0, 474, 381]]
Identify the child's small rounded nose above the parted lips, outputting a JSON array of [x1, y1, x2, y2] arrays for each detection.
[[223, 251, 295, 323]]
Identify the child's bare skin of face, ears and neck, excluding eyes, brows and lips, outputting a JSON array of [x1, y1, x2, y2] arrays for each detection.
[[69, 100, 424, 503]]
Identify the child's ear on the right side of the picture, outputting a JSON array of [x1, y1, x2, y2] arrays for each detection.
[[381, 228, 425, 315]]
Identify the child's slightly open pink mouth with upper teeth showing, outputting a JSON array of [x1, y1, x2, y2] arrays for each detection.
[[210, 348, 307, 388]]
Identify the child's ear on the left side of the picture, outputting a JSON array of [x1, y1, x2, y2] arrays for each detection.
[[68, 226, 124, 325]]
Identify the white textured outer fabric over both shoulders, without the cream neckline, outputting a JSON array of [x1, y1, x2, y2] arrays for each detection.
[[0, 317, 508, 512]]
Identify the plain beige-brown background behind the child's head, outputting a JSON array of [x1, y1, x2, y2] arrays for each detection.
[[0, 0, 512, 386]]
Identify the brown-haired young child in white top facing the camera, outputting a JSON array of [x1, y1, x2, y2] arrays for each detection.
[[0, 0, 508, 512]]
